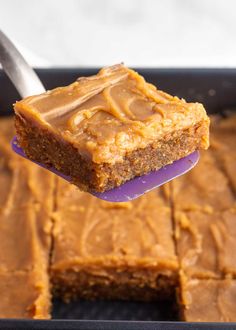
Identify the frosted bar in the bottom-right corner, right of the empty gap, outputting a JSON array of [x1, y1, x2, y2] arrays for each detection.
[[181, 277, 236, 322]]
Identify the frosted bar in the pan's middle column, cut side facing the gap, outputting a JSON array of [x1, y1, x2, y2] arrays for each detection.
[[51, 180, 178, 300]]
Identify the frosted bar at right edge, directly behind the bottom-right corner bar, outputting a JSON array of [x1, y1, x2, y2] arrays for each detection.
[[175, 209, 236, 278]]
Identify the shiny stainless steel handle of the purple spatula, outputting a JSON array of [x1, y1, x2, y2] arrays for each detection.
[[0, 30, 45, 98]]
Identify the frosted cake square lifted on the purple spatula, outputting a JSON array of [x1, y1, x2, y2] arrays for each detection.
[[14, 65, 209, 191]]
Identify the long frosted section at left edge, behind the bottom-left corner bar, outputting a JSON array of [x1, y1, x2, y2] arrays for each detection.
[[0, 119, 55, 271]]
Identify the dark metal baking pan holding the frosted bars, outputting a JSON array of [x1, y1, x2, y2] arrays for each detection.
[[0, 68, 236, 330]]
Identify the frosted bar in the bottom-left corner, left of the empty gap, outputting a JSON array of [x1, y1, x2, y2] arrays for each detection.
[[0, 271, 51, 319]]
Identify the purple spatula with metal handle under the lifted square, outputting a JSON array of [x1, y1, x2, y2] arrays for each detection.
[[0, 31, 199, 202]]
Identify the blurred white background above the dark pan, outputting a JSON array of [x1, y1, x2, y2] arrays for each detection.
[[0, 0, 236, 67]]
